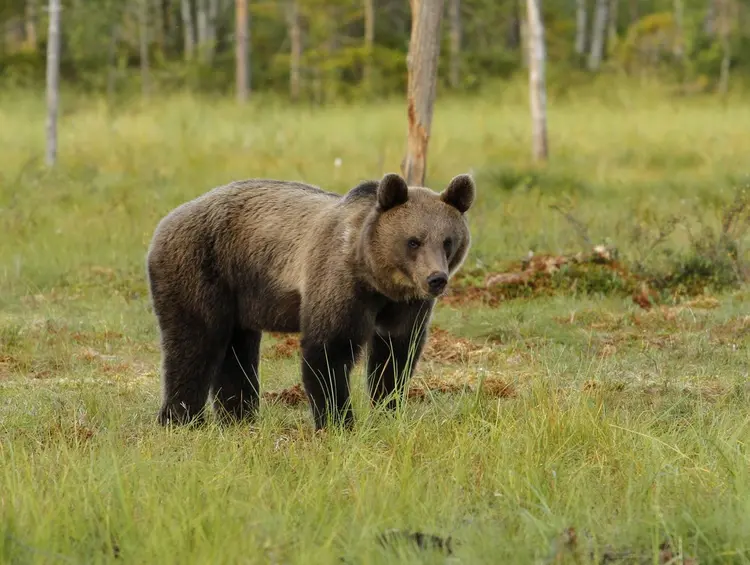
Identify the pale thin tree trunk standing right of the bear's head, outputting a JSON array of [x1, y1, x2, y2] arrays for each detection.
[[526, 0, 549, 161]]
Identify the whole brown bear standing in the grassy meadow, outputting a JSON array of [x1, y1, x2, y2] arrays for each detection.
[[147, 174, 475, 429]]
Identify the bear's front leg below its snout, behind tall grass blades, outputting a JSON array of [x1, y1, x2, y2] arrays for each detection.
[[367, 301, 433, 410]]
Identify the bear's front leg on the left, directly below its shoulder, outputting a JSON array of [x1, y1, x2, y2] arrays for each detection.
[[301, 337, 361, 430]]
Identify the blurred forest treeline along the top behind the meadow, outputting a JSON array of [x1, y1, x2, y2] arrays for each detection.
[[0, 0, 750, 102]]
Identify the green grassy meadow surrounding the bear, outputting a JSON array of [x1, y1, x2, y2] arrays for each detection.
[[0, 83, 750, 564]]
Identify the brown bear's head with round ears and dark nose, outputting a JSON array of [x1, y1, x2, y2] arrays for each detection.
[[362, 173, 476, 300]]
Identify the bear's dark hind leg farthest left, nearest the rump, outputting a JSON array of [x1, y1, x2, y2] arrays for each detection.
[[159, 321, 227, 425]]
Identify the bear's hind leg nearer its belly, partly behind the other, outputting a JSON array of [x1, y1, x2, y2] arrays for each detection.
[[212, 329, 261, 422]]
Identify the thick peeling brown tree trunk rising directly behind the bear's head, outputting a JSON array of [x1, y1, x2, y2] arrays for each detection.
[[401, 0, 443, 185]]
